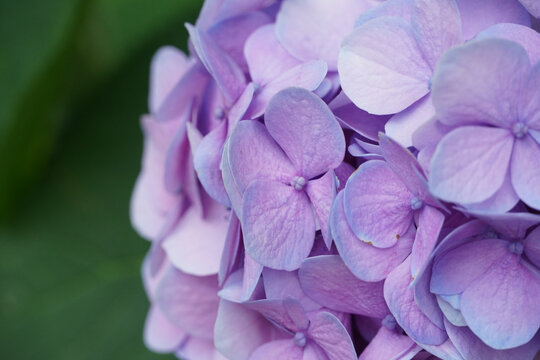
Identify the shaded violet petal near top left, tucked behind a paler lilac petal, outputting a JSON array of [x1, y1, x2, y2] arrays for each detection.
[[208, 11, 271, 72]]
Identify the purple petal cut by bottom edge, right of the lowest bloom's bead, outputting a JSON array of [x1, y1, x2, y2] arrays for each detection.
[[309, 311, 356, 360]]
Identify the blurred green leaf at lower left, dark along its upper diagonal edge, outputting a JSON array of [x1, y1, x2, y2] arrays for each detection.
[[0, 19, 201, 360]]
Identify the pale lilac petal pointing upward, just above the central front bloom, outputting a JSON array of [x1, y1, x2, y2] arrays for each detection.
[[244, 24, 300, 85]]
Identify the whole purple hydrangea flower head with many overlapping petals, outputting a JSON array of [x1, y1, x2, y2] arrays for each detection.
[[131, 0, 540, 360]]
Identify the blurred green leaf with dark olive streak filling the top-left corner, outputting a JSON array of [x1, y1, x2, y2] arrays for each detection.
[[0, 0, 202, 221]]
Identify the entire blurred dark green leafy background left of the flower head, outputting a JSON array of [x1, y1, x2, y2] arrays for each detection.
[[0, 0, 202, 360]]
